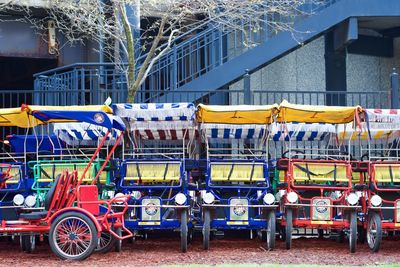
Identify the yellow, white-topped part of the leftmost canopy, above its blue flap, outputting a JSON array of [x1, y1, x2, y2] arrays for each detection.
[[0, 105, 112, 128]]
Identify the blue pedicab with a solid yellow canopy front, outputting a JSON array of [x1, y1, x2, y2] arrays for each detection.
[[196, 104, 278, 250]]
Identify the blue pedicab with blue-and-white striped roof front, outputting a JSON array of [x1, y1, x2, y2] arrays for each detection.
[[113, 103, 196, 252]]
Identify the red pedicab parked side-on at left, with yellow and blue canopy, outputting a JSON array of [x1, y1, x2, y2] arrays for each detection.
[[0, 105, 132, 260]]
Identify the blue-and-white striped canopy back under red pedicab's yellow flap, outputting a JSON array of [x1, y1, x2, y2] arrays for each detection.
[[271, 122, 336, 141]]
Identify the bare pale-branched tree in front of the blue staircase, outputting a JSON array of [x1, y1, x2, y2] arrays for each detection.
[[0, 0, 324, 102]]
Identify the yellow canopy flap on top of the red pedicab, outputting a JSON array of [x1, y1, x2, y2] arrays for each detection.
[[277, 100, 362, 124]]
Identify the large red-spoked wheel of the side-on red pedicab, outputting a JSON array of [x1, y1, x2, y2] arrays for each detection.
[[53, 217, 93, 257]]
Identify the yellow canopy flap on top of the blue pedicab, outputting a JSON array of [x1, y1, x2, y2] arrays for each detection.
[[196, 104, 278, 124]]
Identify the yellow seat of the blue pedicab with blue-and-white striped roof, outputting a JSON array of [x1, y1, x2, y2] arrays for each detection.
[[124, 162, 181, 182]]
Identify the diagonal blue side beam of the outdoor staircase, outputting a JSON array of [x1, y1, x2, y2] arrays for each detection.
[[160, 0, 400, 101]]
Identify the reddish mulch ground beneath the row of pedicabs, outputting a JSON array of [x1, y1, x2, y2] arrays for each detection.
[[0, 236, 400, 267]]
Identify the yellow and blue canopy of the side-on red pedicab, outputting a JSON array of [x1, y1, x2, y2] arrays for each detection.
[[0, 105, 125, 131]]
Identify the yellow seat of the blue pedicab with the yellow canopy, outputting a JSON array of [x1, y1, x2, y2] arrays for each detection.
[[210, 162, 265, 182]]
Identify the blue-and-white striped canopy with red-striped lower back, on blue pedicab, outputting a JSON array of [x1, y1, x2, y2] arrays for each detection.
[[113, 103, 195, 140]]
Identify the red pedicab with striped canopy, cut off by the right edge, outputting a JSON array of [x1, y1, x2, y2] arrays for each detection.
[[343, 109, 400, 252]]
